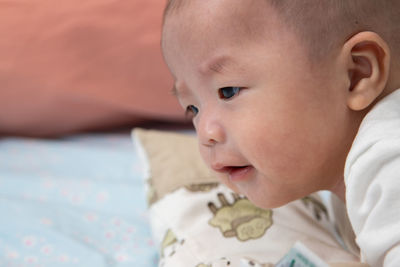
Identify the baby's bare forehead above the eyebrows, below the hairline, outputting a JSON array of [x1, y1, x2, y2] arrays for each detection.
[[162, 0, 292, 81]]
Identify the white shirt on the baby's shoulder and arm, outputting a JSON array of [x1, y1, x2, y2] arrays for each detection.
[[345, 89, 400, 267]]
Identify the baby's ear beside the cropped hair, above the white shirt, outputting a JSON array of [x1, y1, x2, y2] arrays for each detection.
[[342, 32, 390, 111]]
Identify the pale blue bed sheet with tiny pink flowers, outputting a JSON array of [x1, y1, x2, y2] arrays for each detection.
[[0, 132, 158, 267]]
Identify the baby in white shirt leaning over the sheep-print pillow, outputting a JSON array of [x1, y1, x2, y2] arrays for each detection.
[[162, 0, 400, 266]]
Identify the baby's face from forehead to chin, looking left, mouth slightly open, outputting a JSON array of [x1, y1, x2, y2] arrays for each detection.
[[163, 0, 351, 208]]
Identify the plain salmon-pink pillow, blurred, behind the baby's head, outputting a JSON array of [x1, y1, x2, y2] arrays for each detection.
[[0, 0, 184, 136]]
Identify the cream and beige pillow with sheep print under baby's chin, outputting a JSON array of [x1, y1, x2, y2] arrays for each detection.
[[133, 129, 364, 267]]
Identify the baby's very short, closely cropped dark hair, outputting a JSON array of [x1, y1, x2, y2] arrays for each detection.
[[164, 0, 400, 62]]
